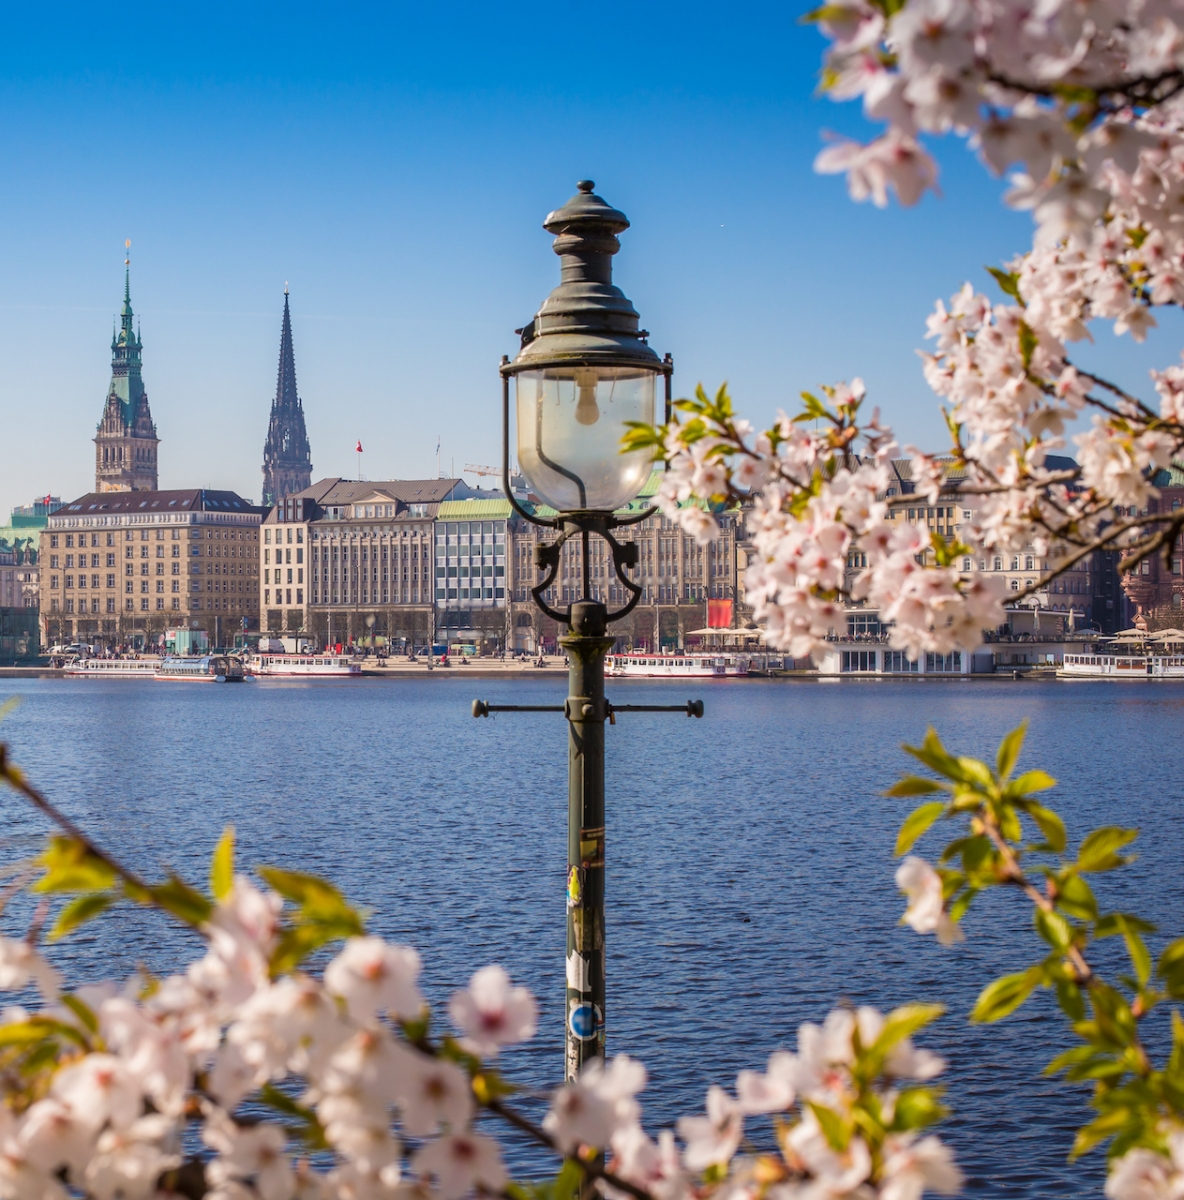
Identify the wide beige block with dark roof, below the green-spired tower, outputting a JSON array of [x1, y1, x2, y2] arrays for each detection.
[[40, 488, 264, 646]]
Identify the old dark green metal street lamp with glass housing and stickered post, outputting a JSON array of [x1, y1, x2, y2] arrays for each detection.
[[473, 180, 703, 1079]]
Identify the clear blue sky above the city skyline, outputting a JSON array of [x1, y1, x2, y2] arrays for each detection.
[[0, 0, 1178, 520]]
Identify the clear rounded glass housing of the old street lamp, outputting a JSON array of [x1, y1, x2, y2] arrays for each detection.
[[515, 366, 657, 512]]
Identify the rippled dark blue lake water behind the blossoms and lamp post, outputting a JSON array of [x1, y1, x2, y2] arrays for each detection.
[[0, 672, 1184, 1196]]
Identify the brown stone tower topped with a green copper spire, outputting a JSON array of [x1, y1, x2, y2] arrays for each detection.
[[95, 263, 160, 492]]
